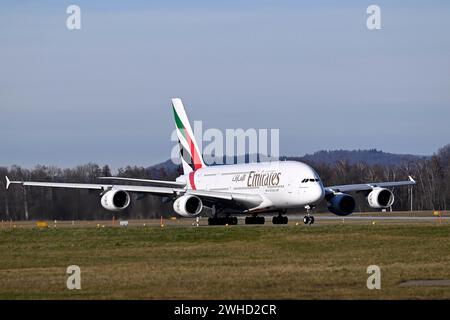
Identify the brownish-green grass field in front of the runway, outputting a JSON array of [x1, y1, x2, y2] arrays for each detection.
[[0, 223, 450, 299]]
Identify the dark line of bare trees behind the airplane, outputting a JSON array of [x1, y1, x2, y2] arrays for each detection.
[[0, 144, 450, 220]]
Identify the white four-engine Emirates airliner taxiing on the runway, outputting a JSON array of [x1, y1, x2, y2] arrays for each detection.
[[6, 99, 415, 225]]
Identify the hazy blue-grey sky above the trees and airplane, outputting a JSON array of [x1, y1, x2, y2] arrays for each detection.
[[0, 1, 450, 168]]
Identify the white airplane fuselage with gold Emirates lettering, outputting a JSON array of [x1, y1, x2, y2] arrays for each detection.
[[185, 161, 325, 209]]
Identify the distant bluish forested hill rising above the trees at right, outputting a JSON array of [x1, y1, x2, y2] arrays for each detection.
[[281, 149, 430, 166]]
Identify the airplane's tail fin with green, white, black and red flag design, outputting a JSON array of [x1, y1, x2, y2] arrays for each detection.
[[172, 98, 206, 174]]
